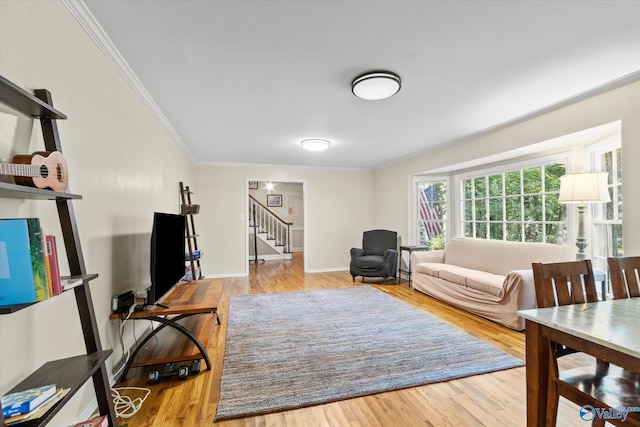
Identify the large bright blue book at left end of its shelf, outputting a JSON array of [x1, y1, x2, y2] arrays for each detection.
[[0, 218, 41, 305]]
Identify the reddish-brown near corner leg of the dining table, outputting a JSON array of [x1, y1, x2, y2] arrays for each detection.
[[525, 320, 549, 427]]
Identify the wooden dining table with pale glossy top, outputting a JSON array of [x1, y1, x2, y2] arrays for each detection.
[[518, 298, 640, 427]]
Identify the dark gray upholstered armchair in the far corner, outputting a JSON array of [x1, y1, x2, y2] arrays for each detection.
[[349, 230, 398, 282]]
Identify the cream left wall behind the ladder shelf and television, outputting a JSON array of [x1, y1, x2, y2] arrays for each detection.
[[0, 1, 193, 425]]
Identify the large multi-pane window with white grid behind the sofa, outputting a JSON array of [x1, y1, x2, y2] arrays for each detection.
[[460, 162, 567, 244]]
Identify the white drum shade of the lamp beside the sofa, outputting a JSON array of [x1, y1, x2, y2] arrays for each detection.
[[558, 172, 611, 204]]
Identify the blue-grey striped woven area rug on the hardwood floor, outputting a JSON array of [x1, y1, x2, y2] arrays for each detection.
[[216, 285, 524, 420]]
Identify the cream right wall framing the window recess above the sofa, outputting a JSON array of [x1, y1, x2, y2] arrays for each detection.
[[375, 81, 640, 255]]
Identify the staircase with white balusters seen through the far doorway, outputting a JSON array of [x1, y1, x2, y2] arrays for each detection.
[[249, 195, 292, 259]]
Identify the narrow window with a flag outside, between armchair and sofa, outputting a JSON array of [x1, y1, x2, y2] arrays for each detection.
[[414, 180, 447, 249]]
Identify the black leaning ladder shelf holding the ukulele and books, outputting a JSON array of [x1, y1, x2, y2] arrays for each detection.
[[0, 76, 117, 427]]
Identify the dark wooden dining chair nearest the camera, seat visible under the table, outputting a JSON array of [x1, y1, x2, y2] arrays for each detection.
[[532, 260, 640, 427]]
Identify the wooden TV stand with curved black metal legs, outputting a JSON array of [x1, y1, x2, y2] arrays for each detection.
[[110, 279, 224, 381]]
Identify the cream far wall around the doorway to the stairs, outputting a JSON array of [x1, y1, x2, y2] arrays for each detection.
[[192, 166, 375, 276]]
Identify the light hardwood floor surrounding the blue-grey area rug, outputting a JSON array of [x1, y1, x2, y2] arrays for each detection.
[[117, 255, 591, 427]]
